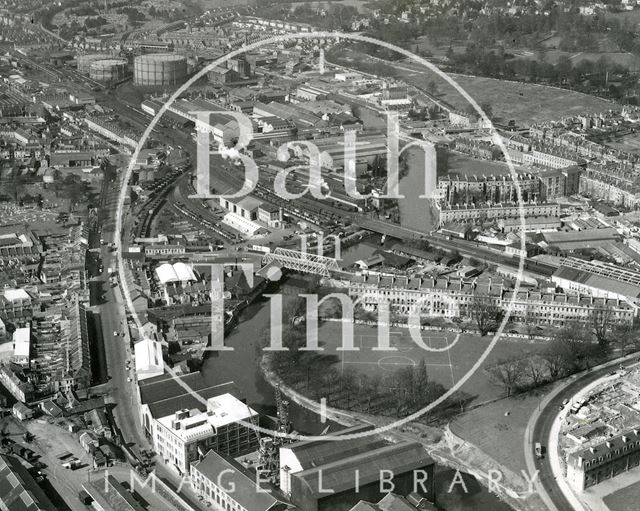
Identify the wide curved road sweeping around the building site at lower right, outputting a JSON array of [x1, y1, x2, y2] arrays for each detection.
[[524, 353, 638, 511]]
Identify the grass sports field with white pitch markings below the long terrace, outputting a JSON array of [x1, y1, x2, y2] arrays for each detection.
[[318, 322, 545, 402]]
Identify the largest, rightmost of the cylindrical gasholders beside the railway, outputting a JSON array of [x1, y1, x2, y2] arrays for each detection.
[[133, 53, 187, 87]]
